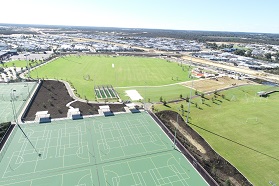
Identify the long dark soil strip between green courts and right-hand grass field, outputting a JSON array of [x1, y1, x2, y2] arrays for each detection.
[[156, 111, 252, 186]]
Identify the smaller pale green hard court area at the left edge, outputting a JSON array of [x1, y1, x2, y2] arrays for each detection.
[[0, 82, 37, 123]]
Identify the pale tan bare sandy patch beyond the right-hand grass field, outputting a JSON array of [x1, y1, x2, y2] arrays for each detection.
[[182, 77, 253, 93]]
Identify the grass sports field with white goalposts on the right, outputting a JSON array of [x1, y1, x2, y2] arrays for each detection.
[[157, 85, 279, 186]]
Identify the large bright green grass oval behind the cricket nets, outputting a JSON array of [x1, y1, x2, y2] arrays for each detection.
[[31, 56, 192, 100]]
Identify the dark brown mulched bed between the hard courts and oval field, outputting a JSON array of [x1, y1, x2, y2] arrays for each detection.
[[23, 80, 125, 121]]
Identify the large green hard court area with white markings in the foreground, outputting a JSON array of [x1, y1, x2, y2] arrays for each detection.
[[0, 113, 207, 186]]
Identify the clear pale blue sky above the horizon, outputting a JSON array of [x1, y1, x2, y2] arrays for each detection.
[[0, 0, 279, 33]]
